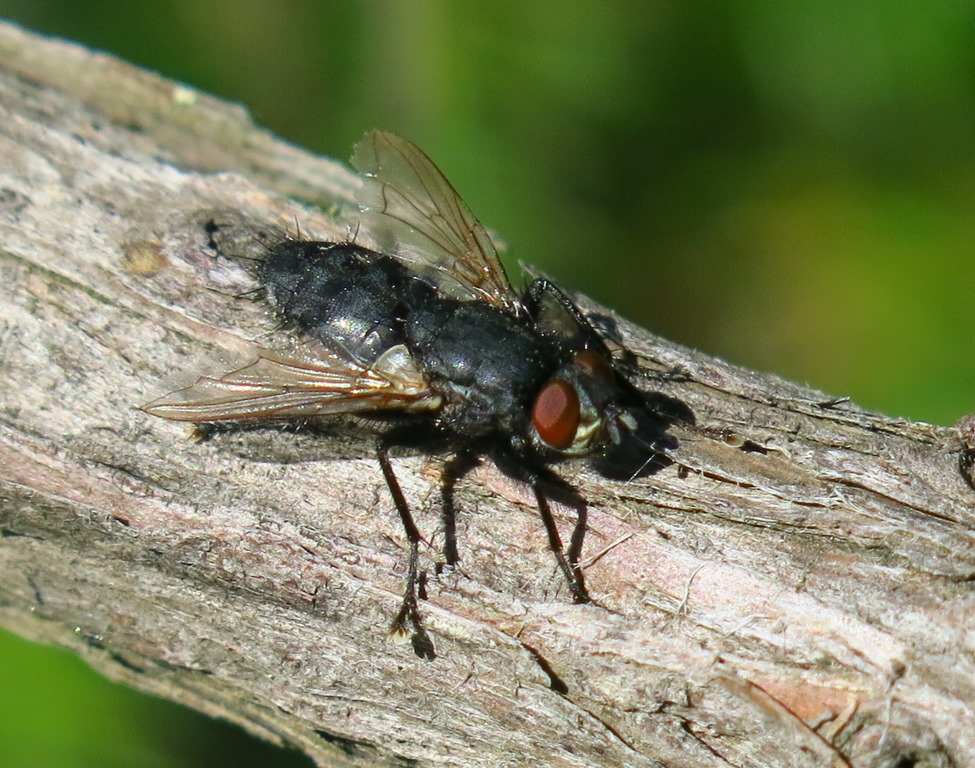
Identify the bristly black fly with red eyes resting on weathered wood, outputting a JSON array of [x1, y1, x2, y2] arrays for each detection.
[[143, 132, 688, 657]]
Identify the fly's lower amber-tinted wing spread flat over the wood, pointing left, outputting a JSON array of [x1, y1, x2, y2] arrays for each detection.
[[142, 345, 440, 423]]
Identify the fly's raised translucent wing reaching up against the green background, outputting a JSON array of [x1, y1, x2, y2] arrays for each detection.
[[352, 131, 524, 315]]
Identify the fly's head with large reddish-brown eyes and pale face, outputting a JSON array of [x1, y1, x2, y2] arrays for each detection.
[[529, 349, 637, 456]]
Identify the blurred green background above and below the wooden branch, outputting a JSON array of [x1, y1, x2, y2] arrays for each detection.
[[0, 0, 975, 768]]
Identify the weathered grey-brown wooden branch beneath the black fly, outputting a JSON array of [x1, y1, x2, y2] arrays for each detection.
[[0, 26, 975, 768]]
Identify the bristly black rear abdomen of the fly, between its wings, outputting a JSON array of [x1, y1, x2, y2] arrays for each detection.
[[260, 240, 433, 362]]
